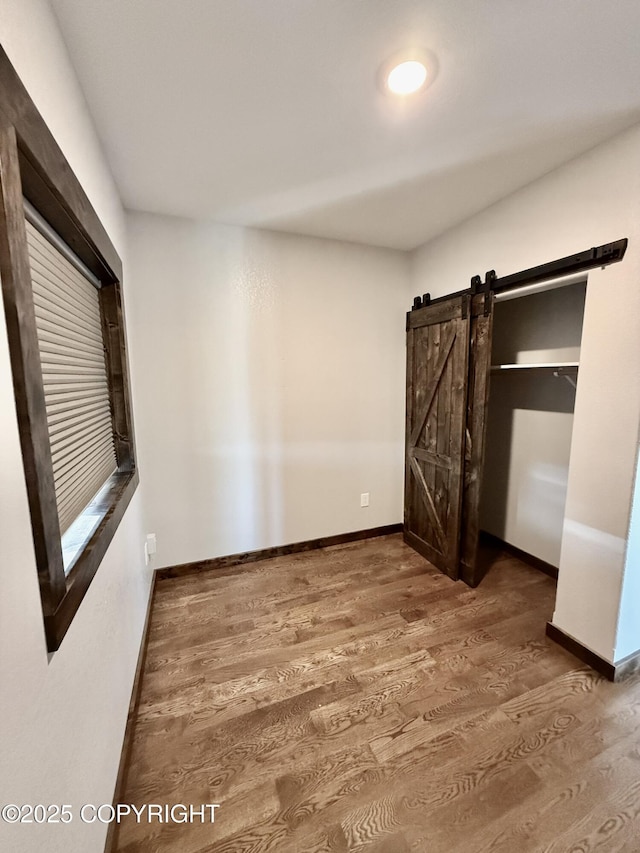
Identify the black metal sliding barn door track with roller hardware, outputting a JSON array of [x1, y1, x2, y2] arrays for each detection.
[[411, 237, 629, 314]]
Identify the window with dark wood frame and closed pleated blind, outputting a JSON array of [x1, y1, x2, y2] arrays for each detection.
[[0, 50, 138, 651]]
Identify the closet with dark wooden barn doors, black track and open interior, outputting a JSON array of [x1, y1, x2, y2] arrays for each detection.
[[404, 240, 627, 586]]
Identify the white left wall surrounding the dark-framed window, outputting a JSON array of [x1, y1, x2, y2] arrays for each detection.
[[0, 0, 149, 853]]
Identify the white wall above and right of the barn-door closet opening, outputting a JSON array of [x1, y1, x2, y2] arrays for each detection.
[[408, 127, 640, 661]]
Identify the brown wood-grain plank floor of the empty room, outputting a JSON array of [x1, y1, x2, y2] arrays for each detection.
[[116, 535, 640, 853]]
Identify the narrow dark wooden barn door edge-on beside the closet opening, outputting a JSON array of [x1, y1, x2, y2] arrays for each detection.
[[460, 293, 494, 586]]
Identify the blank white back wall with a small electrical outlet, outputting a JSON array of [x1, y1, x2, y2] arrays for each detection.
[[128, 214, 408, 566]]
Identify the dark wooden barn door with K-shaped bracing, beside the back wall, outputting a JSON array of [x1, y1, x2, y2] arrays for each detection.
[[404, 296, 470, 578]]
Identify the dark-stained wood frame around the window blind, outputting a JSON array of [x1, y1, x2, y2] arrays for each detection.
[[0, 48, 138, 651]]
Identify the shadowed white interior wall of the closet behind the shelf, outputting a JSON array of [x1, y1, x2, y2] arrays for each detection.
[[480, 284, 586, 567]]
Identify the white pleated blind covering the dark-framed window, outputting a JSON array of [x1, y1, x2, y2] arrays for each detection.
[[25, 205, 117, 534]]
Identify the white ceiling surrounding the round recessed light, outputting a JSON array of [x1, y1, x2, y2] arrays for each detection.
[[51, 0, 640, 249]]
